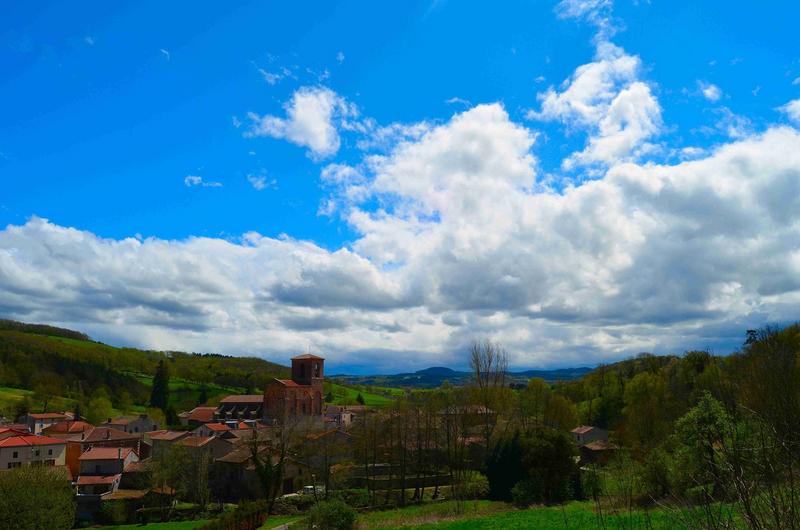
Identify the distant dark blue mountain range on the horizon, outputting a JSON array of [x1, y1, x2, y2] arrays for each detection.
[[331, 366, 593, 388]]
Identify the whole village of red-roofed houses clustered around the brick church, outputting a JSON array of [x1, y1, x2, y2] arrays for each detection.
[[0, 354, 616, 522]]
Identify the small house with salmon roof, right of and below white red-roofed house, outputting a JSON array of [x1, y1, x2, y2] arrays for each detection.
[[77, 447, 139, 495]]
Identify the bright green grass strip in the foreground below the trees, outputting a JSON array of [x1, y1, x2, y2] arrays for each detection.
[[358, 501, 686, 530]]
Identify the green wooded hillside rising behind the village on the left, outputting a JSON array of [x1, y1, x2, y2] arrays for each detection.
[[0, 320, 289, 416]]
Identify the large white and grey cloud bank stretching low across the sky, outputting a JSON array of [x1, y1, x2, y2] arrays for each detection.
[[0, 104, 800, 369]]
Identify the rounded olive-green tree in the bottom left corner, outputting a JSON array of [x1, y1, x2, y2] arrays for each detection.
[[0, 466, 75, 530]]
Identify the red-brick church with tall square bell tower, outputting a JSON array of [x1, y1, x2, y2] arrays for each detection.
[[264, 353, 325, 421]]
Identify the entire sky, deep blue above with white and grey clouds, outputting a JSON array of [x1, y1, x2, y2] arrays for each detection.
[[0, 0, 800, 371]]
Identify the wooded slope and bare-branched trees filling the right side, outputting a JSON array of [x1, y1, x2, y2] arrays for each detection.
[[346, 325, 800, 529]]
